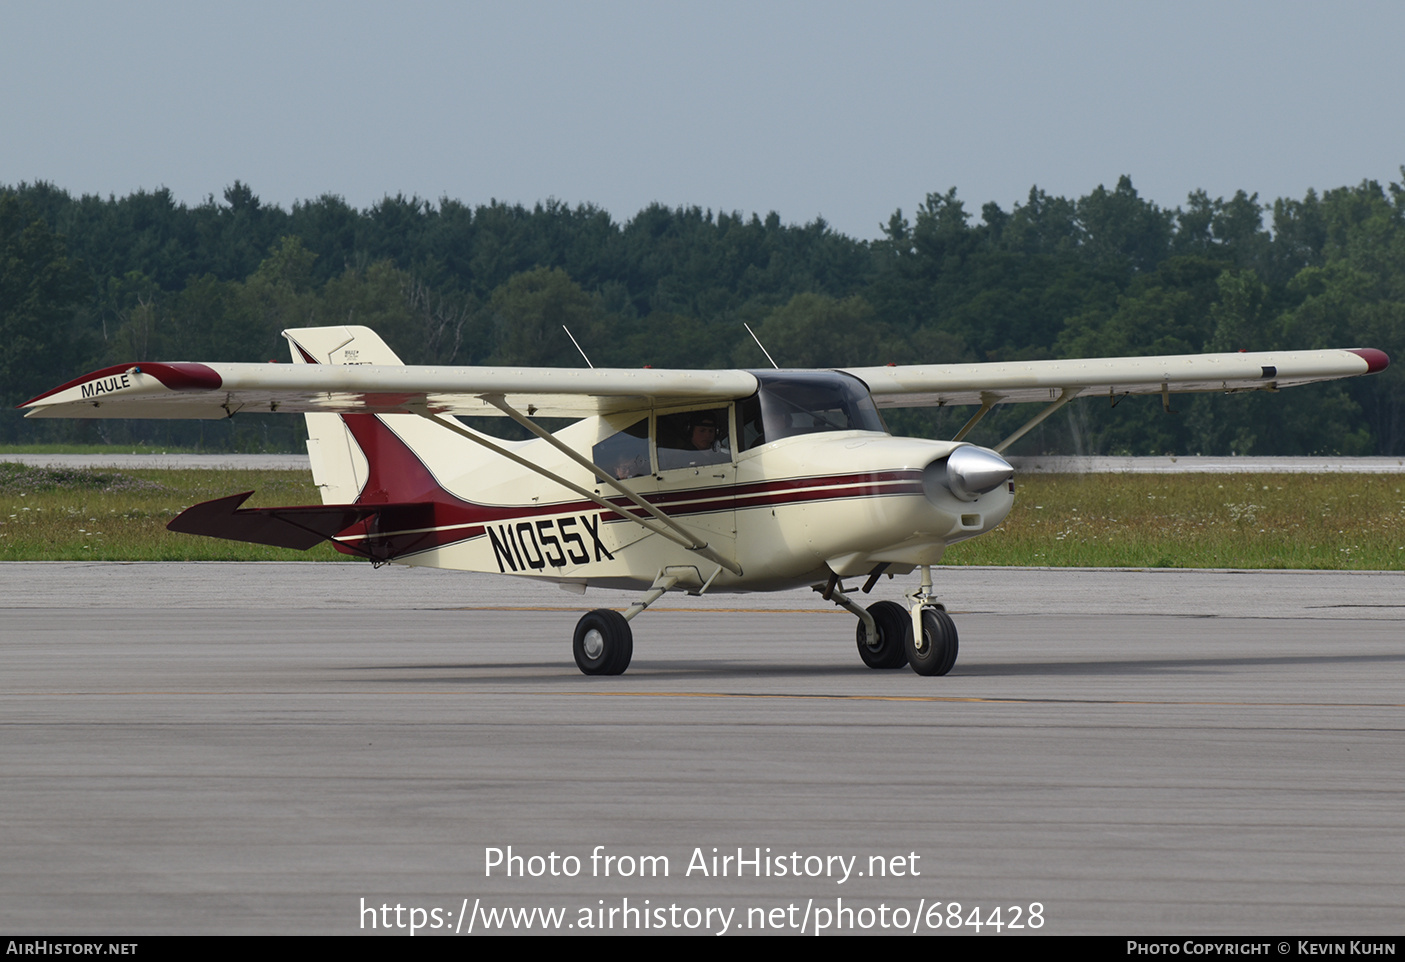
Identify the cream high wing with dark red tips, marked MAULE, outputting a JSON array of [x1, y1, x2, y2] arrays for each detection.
[[21, 320, 1390, 419]]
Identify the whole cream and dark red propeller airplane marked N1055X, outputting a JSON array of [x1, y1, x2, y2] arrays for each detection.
[[21, 327, 1390, 676]]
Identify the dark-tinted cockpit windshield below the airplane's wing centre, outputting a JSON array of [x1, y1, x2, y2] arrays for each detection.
[[736, 371, 887, 451]]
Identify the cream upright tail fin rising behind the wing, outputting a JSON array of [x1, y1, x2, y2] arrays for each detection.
[[282, 326, 400, 504]]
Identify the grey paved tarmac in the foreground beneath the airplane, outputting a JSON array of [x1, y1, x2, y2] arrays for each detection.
[[0, 562, 1405, 935]]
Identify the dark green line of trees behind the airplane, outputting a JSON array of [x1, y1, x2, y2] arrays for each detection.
[[0, 169, 1405, 455]]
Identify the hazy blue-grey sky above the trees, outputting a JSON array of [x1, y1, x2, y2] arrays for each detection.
[[0, 0, 1405, 237]]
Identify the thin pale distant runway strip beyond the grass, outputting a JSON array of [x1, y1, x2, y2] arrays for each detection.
[[8, 454, 1405, 475]]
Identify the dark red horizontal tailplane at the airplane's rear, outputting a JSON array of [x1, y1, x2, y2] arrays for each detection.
[[166, 492, 434, 560]]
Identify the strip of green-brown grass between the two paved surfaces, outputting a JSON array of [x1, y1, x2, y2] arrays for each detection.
[[8, 463, 1405, 570]]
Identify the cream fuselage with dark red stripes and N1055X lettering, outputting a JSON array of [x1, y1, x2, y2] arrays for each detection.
[[327, 406, 1013, 591]]
